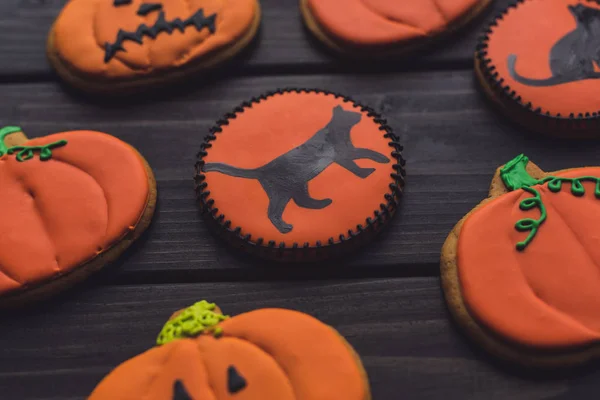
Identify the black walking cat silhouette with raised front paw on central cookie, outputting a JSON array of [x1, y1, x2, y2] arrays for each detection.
[[204, 106, 390, 233]]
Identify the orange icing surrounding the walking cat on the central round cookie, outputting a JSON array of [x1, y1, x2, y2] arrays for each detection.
[[204, 92, 394, 246]]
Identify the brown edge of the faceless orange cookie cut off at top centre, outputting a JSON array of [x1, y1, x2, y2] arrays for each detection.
[[300, 0, 492, 58]]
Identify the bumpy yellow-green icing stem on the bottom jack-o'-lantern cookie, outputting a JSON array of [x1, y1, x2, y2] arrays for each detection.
[[156, 300, 229, 346]]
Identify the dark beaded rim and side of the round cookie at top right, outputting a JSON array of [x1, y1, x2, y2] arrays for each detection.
[[475, 0, 600, 138]]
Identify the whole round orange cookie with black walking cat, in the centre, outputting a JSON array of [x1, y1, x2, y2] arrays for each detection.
[[195, 89, 405, 261]]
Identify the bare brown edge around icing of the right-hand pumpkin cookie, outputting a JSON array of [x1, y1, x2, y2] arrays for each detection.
[[440, 161, 600, 370]]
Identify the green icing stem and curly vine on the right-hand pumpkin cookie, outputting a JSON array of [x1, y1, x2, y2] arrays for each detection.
[[500, 154, 600, 251]]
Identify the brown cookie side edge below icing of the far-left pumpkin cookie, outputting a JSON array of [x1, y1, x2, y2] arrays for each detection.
[[0, 141, 157, 309]]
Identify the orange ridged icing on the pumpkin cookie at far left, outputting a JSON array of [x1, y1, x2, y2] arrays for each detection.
[[0, 131, 154, 302]]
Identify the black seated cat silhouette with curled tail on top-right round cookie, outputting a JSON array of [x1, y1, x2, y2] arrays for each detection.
[[508, 4, 600, 86]]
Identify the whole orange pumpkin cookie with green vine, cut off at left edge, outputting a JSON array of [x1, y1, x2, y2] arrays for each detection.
[[0, 127, 156, 308]]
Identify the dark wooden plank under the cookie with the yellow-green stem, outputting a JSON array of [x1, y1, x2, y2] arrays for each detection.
[[0, 278, 584, 400]]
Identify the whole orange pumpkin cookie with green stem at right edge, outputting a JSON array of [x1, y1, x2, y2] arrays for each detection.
[[441, 155, 600, 366]]
